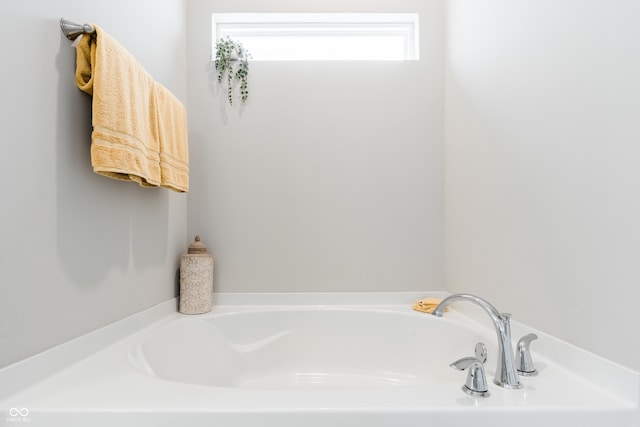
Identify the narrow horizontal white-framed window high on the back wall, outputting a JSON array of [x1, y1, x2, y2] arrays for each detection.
[[213, 13, 418, 61]]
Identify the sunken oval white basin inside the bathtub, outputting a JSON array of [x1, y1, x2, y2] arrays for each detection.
[[130, 309, 495, 389]]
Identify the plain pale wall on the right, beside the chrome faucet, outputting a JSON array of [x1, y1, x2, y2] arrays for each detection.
[[445, 0, 640, 370]]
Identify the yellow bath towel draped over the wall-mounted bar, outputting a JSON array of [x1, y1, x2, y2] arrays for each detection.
[[76, 25, 189, 192]]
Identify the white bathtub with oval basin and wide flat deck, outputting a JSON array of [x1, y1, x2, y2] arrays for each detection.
[[0, 294, 639, 427]]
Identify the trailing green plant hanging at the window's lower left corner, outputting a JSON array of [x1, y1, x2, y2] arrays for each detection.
[[215, 37, 251, 105]]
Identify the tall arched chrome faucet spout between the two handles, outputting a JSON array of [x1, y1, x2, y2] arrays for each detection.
[[432, 294, 522, 389]]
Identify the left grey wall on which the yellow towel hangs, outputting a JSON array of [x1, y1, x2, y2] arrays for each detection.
[[0, 0, 187, 367]]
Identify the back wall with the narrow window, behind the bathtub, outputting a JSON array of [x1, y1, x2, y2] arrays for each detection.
[[188, 0, 444, 292]]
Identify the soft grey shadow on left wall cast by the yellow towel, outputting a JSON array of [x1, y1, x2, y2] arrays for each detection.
[[56, 34, 169, 286]]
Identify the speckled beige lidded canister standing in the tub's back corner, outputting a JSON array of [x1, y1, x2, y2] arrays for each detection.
[[179, 236, 213, 314]]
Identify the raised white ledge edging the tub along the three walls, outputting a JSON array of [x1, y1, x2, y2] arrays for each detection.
[[0, 291, 640, 407]]
